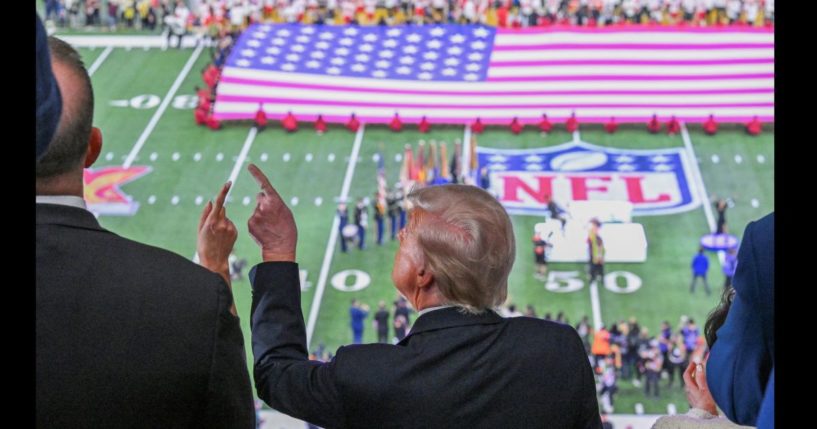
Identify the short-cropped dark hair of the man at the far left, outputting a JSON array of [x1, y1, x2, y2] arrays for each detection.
[[36, 36, 94, 179]]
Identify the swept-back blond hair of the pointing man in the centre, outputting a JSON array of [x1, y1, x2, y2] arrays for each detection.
[[407, 185, 516, 313]]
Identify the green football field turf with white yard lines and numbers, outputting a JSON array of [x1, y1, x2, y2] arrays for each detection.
[[75, 44, 774, 414]]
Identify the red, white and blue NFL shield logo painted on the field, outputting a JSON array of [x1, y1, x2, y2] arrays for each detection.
[[476, 142, 701, 216]]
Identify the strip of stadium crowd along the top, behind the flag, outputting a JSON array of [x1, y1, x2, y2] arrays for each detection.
[[44, 0, 774, 33]]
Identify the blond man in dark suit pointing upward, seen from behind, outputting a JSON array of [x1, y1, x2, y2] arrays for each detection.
[[241, 165, 601, 428]]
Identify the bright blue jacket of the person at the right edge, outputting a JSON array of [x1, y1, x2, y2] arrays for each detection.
[[706, 213, 774, 426]]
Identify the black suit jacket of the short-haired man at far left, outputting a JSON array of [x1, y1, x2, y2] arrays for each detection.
[[36, 204, 255, 428]]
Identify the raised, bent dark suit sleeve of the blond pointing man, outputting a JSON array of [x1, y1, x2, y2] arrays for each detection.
[[245, 262, 344, 427]]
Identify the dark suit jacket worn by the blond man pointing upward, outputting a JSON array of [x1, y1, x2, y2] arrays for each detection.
[[250, 263, 601, 429]]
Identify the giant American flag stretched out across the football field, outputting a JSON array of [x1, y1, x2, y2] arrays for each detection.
[[210, 24, 774, 124]]
